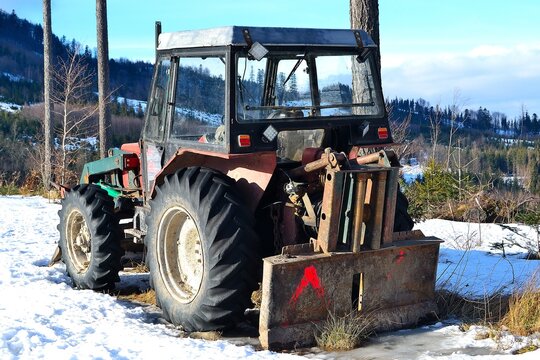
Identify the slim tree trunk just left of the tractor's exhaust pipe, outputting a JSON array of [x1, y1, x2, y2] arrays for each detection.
[[96, 0, 112, 158]]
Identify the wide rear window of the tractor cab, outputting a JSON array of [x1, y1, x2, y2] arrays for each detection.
[[236, 52, 383, 122]]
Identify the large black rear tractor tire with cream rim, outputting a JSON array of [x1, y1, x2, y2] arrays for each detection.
[[146, 167, 260, 331]]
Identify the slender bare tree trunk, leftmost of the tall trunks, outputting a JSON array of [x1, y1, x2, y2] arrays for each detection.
[[42, 0, 53, 190]]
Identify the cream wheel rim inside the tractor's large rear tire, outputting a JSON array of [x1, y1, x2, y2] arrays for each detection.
[[157, 206, 204, 303]]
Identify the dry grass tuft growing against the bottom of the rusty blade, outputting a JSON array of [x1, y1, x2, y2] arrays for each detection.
[[315, 313, 373, 351]]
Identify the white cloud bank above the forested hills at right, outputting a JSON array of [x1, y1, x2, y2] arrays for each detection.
[[382, 43, 540, 117]]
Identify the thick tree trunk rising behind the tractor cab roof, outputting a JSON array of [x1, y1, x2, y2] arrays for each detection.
[[350, 0, 381, 75]]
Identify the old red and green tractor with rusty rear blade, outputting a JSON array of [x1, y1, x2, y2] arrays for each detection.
[[53, 23, 440, 349]]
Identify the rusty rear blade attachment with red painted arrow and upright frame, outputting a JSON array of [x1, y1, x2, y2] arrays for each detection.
[[259, 167, 441, 349]]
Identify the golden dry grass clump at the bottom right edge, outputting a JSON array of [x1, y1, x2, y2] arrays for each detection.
[[500, 272, 540, 336]]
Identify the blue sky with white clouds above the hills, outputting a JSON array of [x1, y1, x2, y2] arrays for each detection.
[[0, 0, 540, 118]]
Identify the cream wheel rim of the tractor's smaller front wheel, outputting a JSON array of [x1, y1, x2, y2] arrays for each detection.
[[66, 210, 92, 273]]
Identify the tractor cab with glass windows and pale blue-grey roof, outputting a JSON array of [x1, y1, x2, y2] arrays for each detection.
[[143, 26, 392, 191]]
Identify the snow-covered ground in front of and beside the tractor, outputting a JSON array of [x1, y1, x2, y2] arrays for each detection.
[[0, 196, 540, 359]]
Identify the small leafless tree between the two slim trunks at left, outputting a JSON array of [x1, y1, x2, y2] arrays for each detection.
[[52, 48, 98, 184]]
